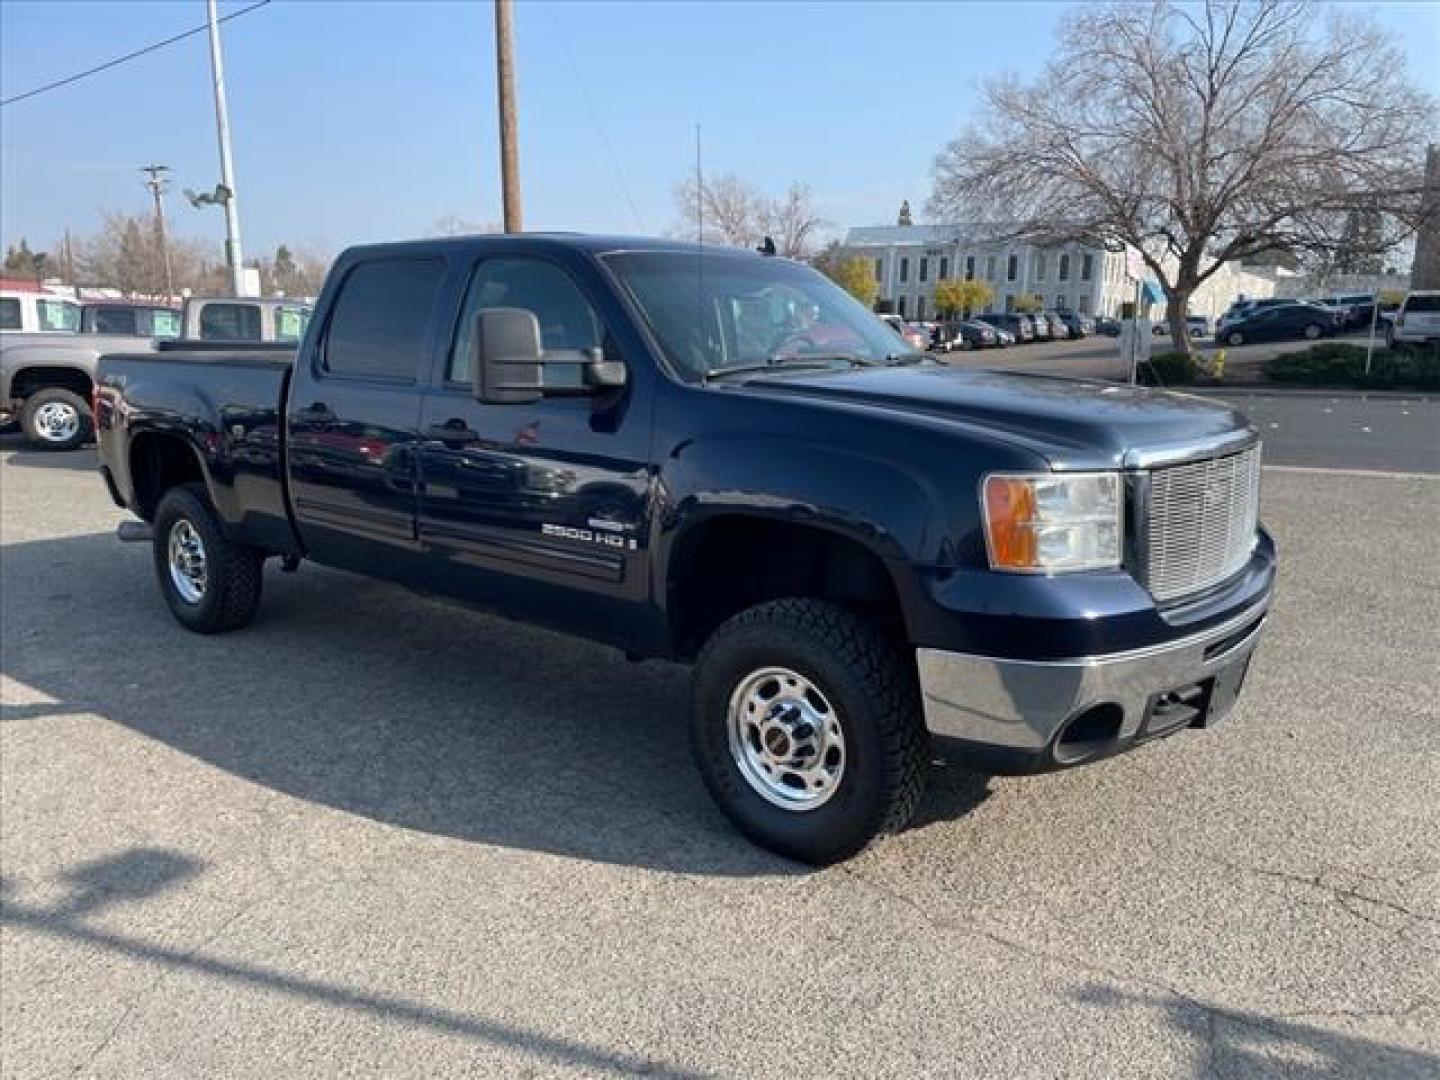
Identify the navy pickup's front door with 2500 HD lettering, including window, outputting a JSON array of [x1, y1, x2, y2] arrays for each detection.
[[418, 255, 651, 639]]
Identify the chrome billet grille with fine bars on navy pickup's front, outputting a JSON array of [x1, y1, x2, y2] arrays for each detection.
[[1142, 444, 1260, 600]]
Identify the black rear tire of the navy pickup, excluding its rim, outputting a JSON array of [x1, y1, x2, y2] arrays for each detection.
[[153, 484, 265, 634]]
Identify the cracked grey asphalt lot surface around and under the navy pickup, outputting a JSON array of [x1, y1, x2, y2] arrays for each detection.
[[0, 438, 1440, 1079]]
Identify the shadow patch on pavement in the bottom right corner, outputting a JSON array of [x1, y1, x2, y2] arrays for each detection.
[[1076, 984, 1440, 1080]]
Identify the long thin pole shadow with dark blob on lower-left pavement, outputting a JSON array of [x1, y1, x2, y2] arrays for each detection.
[[0, 848, 696, 1077]]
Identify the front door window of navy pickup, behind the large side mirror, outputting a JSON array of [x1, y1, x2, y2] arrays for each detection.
[[446, 258, 603, 386]]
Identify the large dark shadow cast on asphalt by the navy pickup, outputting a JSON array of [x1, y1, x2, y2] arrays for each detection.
[[0, 534, 982, 876]]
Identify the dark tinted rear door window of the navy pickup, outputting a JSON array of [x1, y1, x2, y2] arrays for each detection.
[[325, 259, 445, 382]]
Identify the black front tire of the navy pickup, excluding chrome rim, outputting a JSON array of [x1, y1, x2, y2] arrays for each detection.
[[691, 599, 927, 865]]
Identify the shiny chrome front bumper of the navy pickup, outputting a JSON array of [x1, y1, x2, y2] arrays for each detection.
[[916, 598, 1269, 768]]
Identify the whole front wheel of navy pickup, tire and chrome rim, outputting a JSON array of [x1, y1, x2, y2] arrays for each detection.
[[691, 599, 926, 865]]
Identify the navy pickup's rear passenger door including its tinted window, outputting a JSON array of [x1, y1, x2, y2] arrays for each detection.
[[287, 256, 445, 577]]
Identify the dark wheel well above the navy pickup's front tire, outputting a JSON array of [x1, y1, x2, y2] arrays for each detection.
[[667, 517, 904, 657]]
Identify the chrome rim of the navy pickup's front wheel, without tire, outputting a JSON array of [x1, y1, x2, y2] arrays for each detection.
[[726, 668, 845, 811]]
